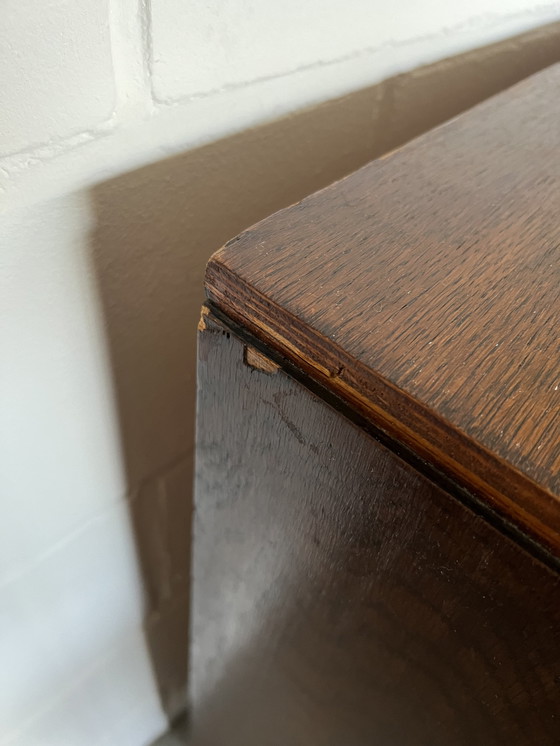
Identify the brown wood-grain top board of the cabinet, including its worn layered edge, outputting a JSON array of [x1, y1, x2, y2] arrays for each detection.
[[206, 66, 560, 554]]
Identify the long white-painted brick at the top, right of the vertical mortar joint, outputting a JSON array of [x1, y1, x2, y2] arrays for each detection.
[[152, 0, 556, 101]]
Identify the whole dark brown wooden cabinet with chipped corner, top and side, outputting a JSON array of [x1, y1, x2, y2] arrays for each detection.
[[191, 67, 560, 746]]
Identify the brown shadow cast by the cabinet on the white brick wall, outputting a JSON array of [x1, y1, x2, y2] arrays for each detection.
[[87, 18, 560, 718]]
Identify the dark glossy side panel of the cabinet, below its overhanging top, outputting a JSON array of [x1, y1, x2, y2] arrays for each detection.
[[190, 316, 560, 746]]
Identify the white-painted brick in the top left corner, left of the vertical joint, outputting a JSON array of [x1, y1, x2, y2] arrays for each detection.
[[0, 0, 115, 155]]
